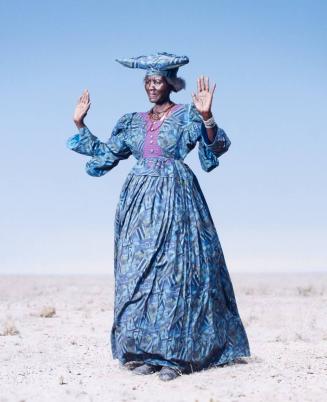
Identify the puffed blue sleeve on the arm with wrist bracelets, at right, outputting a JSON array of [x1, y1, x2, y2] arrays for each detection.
[[187, 103, 231, 172]]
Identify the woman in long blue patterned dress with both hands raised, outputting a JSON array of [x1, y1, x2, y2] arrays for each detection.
[[67, 52, 250, 381]]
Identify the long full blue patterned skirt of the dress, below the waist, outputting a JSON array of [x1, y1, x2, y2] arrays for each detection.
[[110, 158, 250, 372]]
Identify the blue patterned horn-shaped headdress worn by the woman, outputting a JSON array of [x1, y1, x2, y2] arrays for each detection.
[[116, 52, 189, 92]]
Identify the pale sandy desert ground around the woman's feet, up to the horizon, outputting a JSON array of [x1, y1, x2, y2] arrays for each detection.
[[0, 273, 327, 402]]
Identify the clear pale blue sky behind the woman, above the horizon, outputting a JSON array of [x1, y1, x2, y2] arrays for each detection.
[[0, 0, 327, 274]]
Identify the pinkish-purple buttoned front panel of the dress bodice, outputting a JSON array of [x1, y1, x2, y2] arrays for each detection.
[[141, 104, 183, 158]]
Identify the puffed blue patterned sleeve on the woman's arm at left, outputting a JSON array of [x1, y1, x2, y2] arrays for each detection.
[[66, 113, 132, 177]]
